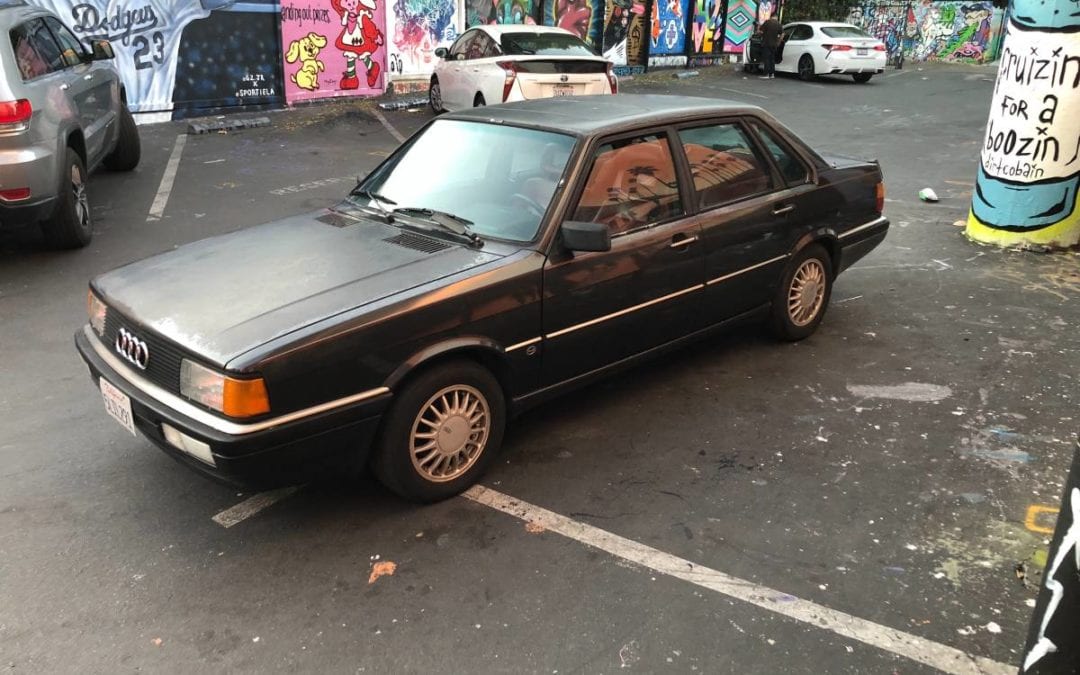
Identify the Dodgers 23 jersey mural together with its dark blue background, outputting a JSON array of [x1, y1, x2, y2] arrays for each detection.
[[29, 0, 280, 112]]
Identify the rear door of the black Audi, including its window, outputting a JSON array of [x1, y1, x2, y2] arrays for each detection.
[[678, 119, 796, 323]]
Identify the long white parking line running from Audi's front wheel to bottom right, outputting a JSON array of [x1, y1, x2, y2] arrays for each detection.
[[464, 485, 1017, 675]]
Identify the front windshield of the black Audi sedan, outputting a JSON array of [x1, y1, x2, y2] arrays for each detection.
[[349, 120, 575, 242]]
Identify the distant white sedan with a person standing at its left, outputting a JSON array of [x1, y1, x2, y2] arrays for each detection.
[[777, 22, 888, 82]]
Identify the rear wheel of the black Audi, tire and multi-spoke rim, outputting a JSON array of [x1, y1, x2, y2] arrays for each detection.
[[770, 244, 833, 341]]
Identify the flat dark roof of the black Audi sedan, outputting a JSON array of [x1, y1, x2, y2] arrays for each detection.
[[447, 94, 764, 136]]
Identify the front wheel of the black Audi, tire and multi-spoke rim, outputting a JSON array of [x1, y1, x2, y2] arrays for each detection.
[[372, 361, 507, 503]]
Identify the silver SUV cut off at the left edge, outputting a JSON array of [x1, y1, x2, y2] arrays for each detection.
[[0, 0, 140, 248]]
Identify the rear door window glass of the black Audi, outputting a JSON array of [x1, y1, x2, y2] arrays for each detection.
[[678, 122, 775, 210]]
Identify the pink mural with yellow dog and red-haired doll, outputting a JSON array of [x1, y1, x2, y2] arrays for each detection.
[[281, 0, 387, 104]]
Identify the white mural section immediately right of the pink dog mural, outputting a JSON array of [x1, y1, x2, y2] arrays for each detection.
[[387, 0, 458, 76]]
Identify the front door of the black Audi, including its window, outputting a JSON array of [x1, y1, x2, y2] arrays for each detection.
[[543, 130, 704, 384]]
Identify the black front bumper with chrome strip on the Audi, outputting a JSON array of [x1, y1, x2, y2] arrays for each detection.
[[75, 326, 390, 487]]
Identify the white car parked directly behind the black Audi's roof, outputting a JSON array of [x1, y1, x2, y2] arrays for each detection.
[[428, 24, 619, 112]]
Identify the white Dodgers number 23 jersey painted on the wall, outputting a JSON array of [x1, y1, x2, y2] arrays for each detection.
[[29, 0, 272, 112]]
